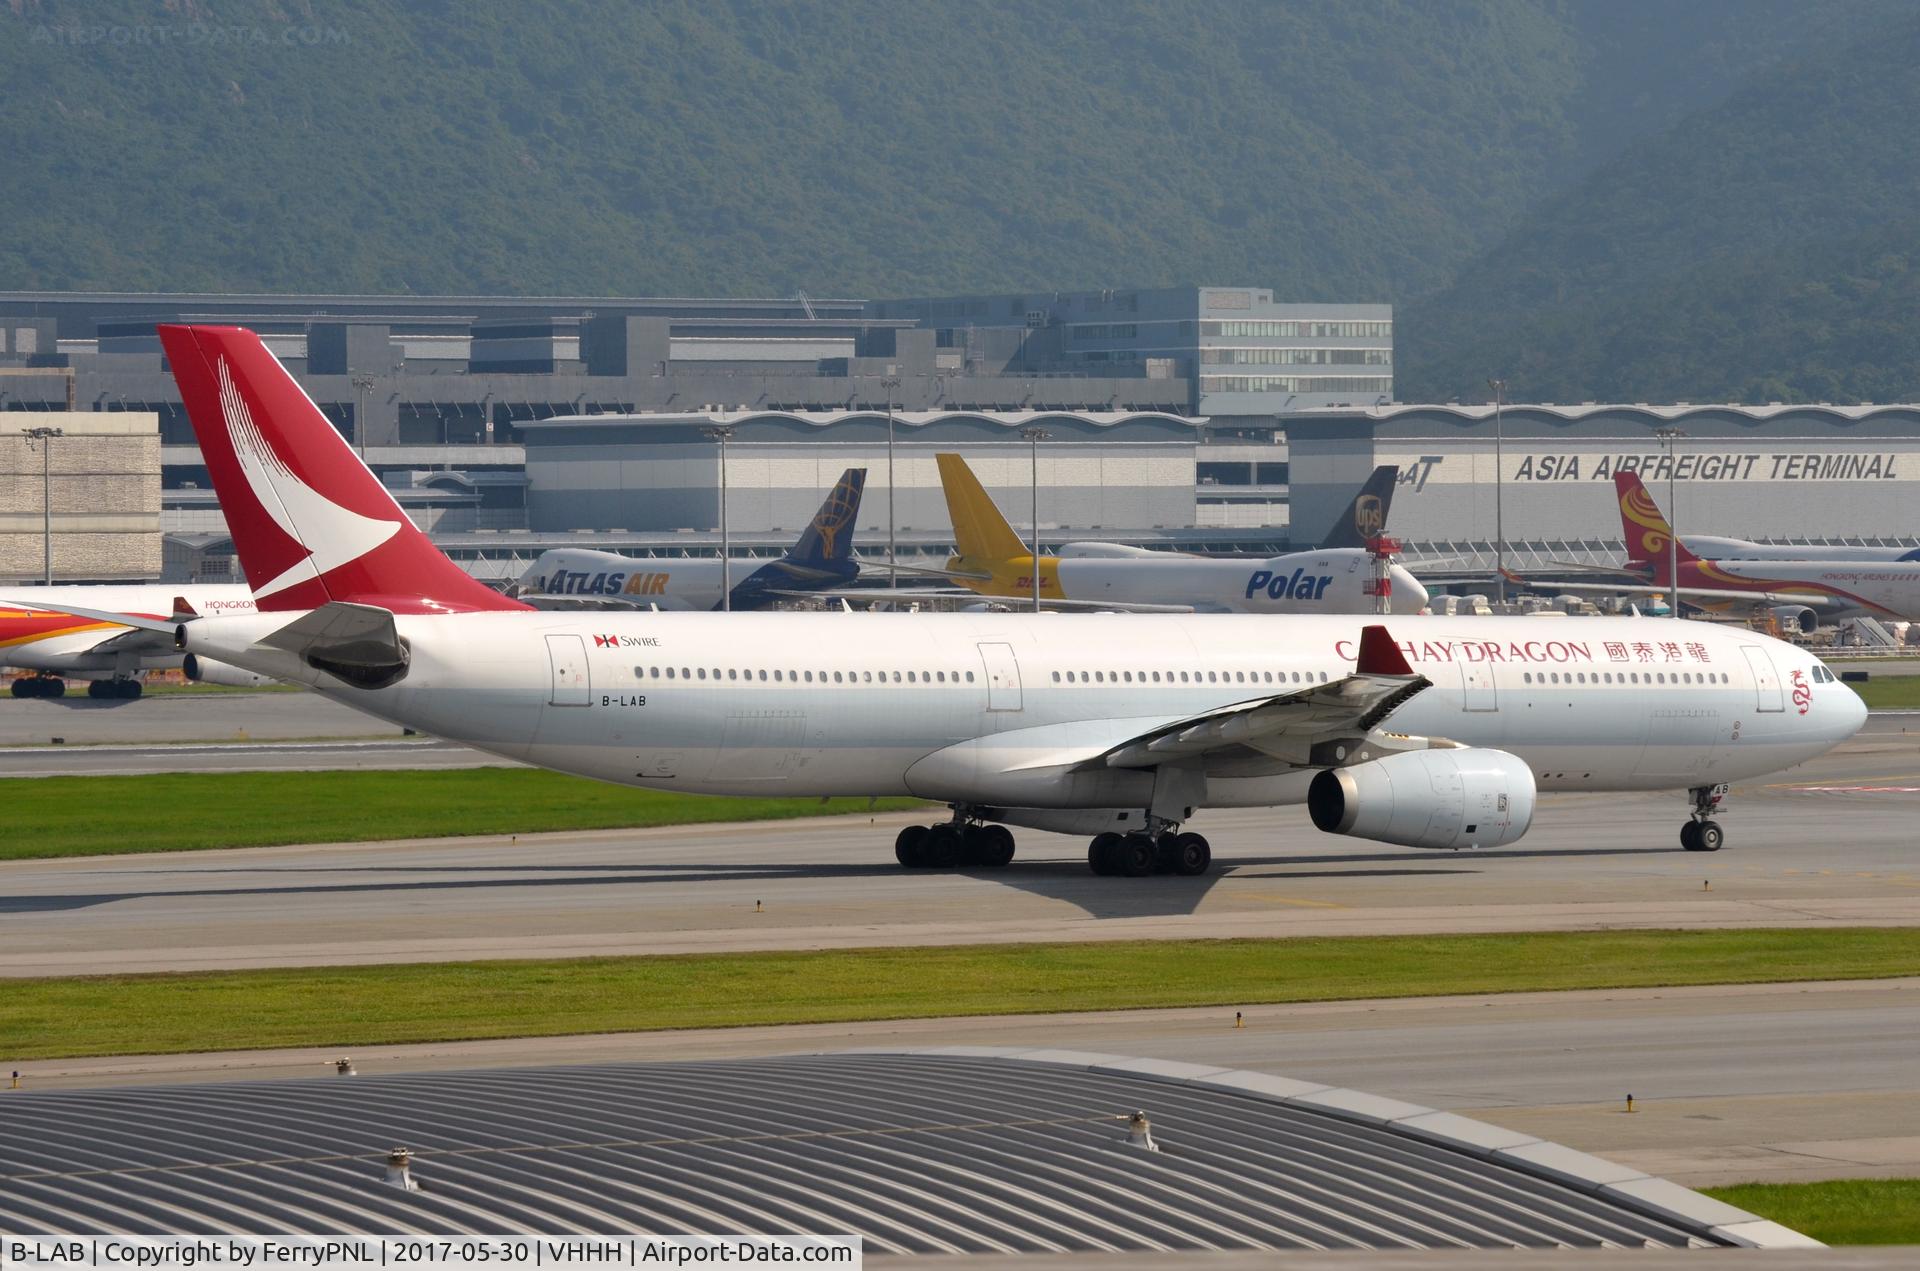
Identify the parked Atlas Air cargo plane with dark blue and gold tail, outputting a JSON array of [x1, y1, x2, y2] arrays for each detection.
[[516, 468, 866, 609]]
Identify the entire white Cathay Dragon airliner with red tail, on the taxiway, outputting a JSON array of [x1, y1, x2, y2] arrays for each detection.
[[56, 326, 1866, 875]]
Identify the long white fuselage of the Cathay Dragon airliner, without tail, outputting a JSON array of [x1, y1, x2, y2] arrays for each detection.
[[188, 612, 1866, 833]]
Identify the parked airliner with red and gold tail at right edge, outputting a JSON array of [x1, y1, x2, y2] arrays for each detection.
[[1512, 472, 1920, 634]]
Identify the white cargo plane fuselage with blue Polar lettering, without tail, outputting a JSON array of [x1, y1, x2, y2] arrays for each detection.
[[1056, 547, 1427, 614]]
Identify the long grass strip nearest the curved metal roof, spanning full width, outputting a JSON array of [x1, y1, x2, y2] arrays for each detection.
[[0, 927, 1920, 1060]]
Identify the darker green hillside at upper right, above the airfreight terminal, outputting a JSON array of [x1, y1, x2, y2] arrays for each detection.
[[1398, 8, 1920, 401]]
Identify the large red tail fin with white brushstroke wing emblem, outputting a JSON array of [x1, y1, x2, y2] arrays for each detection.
[[159, 326, 524, 612]]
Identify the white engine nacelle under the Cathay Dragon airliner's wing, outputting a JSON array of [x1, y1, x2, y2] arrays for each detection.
[[1308, 749, 1534, 847]]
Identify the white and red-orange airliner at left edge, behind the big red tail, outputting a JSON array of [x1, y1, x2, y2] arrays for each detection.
[[0, 584, 269, 697]]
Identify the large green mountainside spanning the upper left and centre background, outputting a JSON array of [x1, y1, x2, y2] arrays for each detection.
[[0, 0, 1885, 300]]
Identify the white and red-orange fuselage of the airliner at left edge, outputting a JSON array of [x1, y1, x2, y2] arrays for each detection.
[[0, 582, 253, 678]]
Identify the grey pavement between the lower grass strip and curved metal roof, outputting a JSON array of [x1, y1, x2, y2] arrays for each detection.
[[18, 979, 1920, 1187]]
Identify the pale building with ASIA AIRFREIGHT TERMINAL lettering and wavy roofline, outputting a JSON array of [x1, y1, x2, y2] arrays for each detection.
[[1286, 403, 1920, 568]]
